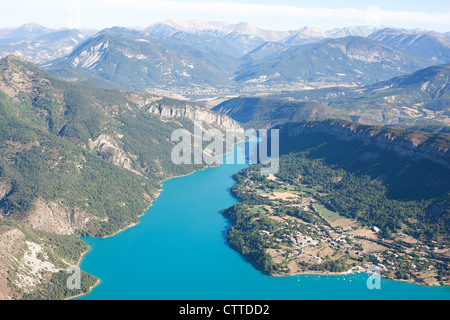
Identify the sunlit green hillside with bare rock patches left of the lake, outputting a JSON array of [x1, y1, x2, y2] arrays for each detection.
[[0, 56, 242, 298]]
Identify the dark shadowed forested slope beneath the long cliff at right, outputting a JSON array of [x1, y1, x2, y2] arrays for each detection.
[[278, 120, 450, 206]]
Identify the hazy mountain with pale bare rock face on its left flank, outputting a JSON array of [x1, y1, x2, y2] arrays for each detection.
[[47, 30, 239, 91]]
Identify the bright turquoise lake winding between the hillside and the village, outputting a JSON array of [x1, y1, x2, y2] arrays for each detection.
[[78, 144, 450, 300]]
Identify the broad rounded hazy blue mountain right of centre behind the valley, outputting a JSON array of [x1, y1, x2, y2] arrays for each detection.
[[236, 37, 426, 86]]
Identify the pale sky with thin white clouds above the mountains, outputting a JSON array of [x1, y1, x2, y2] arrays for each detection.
[[0, 0, 450, 32]]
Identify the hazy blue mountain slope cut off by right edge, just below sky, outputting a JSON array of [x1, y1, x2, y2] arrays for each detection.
[[369, 28, 450, 64]]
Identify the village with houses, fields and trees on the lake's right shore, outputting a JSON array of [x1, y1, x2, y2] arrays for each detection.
[[232, 170, 449, 285]]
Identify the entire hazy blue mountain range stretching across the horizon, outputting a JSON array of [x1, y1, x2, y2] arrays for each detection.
[[0, 20, 450, 98]]
